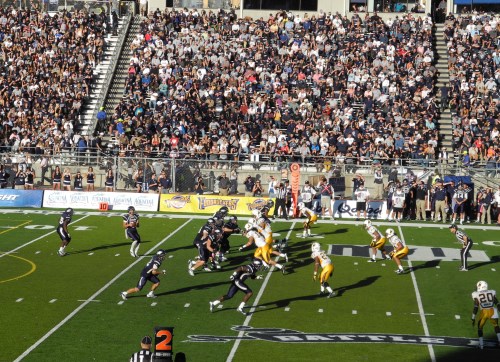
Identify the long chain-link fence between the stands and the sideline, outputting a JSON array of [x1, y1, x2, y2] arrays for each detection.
[[0, 149, 500, 194]]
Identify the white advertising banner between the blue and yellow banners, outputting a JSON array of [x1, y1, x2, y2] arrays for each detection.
[[43, 190, 159, 211]]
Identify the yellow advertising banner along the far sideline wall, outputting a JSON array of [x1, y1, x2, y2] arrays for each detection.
[[160, 194, 274, 215]]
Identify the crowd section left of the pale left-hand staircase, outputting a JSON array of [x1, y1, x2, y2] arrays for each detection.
[[0, 4, 107, 158]]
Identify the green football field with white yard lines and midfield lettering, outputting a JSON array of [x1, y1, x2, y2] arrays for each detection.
[[0, 209, 500, 362]]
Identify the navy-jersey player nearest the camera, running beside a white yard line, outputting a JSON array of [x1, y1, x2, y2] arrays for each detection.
[[209, 258, 263, 315]]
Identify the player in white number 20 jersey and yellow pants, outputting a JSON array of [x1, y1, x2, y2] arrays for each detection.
[[472, 280, 500, 349]]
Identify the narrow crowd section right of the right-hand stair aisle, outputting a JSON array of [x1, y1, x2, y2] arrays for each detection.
[[444, 12, 500, 169]]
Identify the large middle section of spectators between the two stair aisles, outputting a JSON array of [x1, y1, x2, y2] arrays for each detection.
[[107, 9, 439, 168]]
